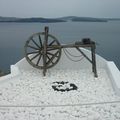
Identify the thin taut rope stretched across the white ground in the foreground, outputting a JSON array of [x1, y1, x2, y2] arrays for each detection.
[[0, 101, 120, 108]]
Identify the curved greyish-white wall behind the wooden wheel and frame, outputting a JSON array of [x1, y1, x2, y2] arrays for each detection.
[[15, 48, 106, 70]]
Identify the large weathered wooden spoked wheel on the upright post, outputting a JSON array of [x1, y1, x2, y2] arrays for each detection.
[[25, 32, 61, 69]]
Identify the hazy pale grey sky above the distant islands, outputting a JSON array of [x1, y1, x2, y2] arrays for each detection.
[[0, 0, 120, 18]]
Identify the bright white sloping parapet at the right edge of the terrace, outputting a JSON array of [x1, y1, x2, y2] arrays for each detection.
[[107, 61, 120, 96]]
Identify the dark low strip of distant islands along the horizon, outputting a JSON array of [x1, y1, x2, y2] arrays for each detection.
[[0, 16, 120, 23]]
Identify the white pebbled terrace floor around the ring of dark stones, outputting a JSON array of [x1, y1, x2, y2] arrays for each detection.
[[0, 69, 120, 120]]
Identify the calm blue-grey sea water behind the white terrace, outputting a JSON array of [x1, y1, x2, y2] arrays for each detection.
[[0, 21, 120, 71]]
